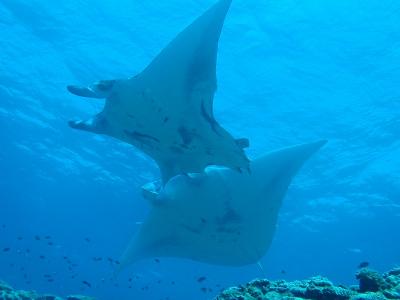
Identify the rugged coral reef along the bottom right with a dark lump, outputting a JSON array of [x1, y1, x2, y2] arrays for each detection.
[[214, 268, 400, 300]]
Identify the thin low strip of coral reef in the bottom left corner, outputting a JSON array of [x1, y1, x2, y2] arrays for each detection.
[[0, 281, 94, 300]]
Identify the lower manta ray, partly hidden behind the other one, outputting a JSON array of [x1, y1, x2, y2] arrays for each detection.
[[121, 141, 325, 267]]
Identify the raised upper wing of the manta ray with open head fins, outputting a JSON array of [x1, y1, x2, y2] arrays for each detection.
[[141, 0, 232, 119]]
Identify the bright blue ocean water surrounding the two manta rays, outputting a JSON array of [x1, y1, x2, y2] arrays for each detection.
[[0, 0, 400, 300]]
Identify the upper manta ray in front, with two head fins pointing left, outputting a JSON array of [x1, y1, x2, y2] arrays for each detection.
[[68, 0, 249, 183]]
